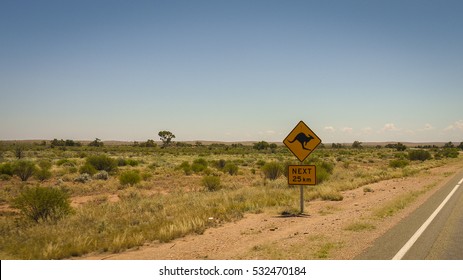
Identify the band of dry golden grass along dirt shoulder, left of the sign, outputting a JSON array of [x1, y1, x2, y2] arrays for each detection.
[[0, 187, 297, 259]]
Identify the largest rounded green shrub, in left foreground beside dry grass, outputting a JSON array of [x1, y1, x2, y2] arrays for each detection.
[[11, 186, 72, 223]]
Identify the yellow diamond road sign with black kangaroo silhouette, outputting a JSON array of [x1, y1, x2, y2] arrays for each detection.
[[283, 121, 322, 162]]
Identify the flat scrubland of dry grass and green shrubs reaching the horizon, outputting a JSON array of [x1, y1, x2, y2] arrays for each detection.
[[0, 139, 463, 259]]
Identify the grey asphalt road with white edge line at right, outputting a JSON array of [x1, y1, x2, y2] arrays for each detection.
[[356, 171, 463, 260]]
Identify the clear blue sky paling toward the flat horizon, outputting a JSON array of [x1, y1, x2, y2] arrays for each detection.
[[0, 0, 463, 143]]
